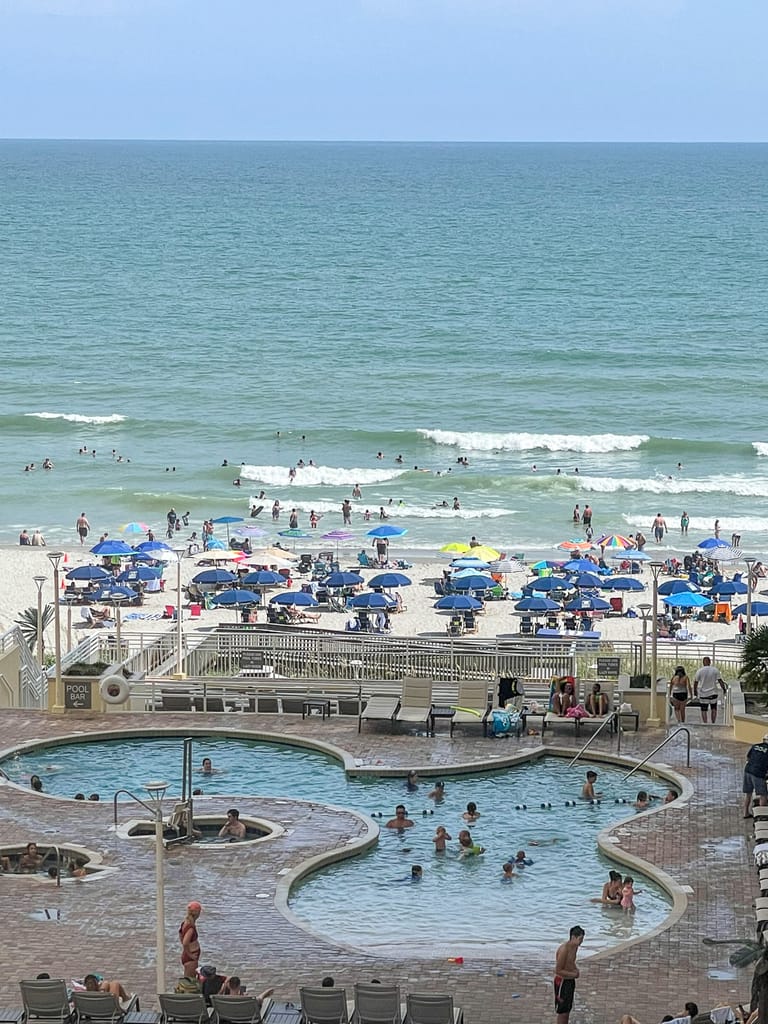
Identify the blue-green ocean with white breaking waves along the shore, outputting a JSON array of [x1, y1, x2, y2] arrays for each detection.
[[0, 141, 768, 557]]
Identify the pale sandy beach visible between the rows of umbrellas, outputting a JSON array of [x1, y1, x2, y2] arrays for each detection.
[[0, 547, 745, 650]]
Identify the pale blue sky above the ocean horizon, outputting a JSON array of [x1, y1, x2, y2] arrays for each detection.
[[0, 0, 768, 142]]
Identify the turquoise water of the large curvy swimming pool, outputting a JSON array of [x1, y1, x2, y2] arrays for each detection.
[[2, 738, 669, 955]]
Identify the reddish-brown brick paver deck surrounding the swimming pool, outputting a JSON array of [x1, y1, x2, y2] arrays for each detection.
[[0, 711, 756, 1024]]
